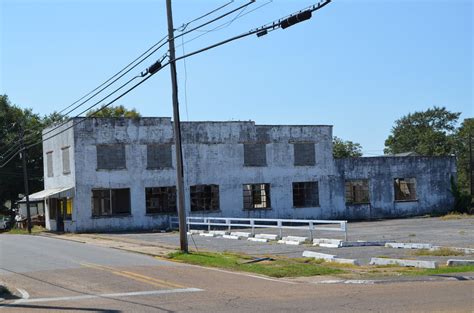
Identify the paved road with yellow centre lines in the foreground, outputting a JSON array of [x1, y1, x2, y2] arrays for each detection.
[[0, 235, 474, 313]]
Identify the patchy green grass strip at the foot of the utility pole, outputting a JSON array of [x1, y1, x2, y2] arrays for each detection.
[[168, 252, 345, 277]]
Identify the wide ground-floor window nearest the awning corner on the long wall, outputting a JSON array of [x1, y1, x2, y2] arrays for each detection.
[[92, 188, 130, 216]]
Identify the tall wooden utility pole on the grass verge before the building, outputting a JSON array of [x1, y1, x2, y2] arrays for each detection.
[[166, 0, 188, 253]]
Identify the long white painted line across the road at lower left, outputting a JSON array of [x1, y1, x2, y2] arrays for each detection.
[[5, 288, 203, 307]]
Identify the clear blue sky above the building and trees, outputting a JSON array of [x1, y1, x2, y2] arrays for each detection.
[[0, 0, 474, 156]]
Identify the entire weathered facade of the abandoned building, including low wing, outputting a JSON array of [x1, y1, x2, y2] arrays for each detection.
[[43, 118, 456, 232]]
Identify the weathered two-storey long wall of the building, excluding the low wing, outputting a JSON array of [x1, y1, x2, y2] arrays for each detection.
[[75, 118, 336, 231]]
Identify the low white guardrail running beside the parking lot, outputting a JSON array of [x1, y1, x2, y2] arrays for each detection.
[[170, 216, 347, 241]]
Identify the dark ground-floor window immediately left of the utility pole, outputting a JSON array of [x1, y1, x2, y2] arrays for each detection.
[[145, 186, 177, 214]]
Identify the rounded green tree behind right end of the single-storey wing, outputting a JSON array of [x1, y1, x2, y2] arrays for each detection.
[[384, 106, 461, 156]]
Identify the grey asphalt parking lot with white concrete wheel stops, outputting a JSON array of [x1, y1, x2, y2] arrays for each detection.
[[107, 217, 474, 264]]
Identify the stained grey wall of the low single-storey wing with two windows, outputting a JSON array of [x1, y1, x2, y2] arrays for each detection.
[[334, 156, 456, 219]]
